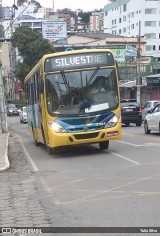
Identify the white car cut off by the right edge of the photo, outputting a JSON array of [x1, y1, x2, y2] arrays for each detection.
[[144, 103, 160, 134]]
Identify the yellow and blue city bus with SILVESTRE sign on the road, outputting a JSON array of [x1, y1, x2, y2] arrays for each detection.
[[25, 49, 121, 154]]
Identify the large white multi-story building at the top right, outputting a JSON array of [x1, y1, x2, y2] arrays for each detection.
[[104, 0, 160, 61]]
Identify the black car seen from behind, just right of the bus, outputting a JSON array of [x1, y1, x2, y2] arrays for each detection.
[[121, 99, 142, 126]]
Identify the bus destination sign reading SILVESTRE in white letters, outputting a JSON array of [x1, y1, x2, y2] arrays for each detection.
[[45, 52, 114, 72]]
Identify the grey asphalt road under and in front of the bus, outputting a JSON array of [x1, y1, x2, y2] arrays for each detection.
[[8, 117, 160, 232]]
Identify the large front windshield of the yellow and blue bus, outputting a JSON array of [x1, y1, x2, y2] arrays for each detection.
[[45, 67, 119, 115]]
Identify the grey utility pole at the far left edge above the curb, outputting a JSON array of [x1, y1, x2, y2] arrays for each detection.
[[0, 55, 8, 133]]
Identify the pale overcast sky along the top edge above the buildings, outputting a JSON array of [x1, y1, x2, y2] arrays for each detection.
[[2, 0, 108, 11]]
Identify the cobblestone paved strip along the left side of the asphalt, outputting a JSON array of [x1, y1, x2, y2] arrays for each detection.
[[0, 130, 52, 230]]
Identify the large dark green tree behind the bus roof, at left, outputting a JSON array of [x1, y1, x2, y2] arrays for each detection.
[[11, 26, 55, 84]]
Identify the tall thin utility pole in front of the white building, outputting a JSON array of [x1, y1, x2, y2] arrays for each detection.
[[136, 21, 142, 104]]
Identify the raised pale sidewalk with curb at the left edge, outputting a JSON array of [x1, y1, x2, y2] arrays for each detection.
[[0, 127, 10, 171]]
